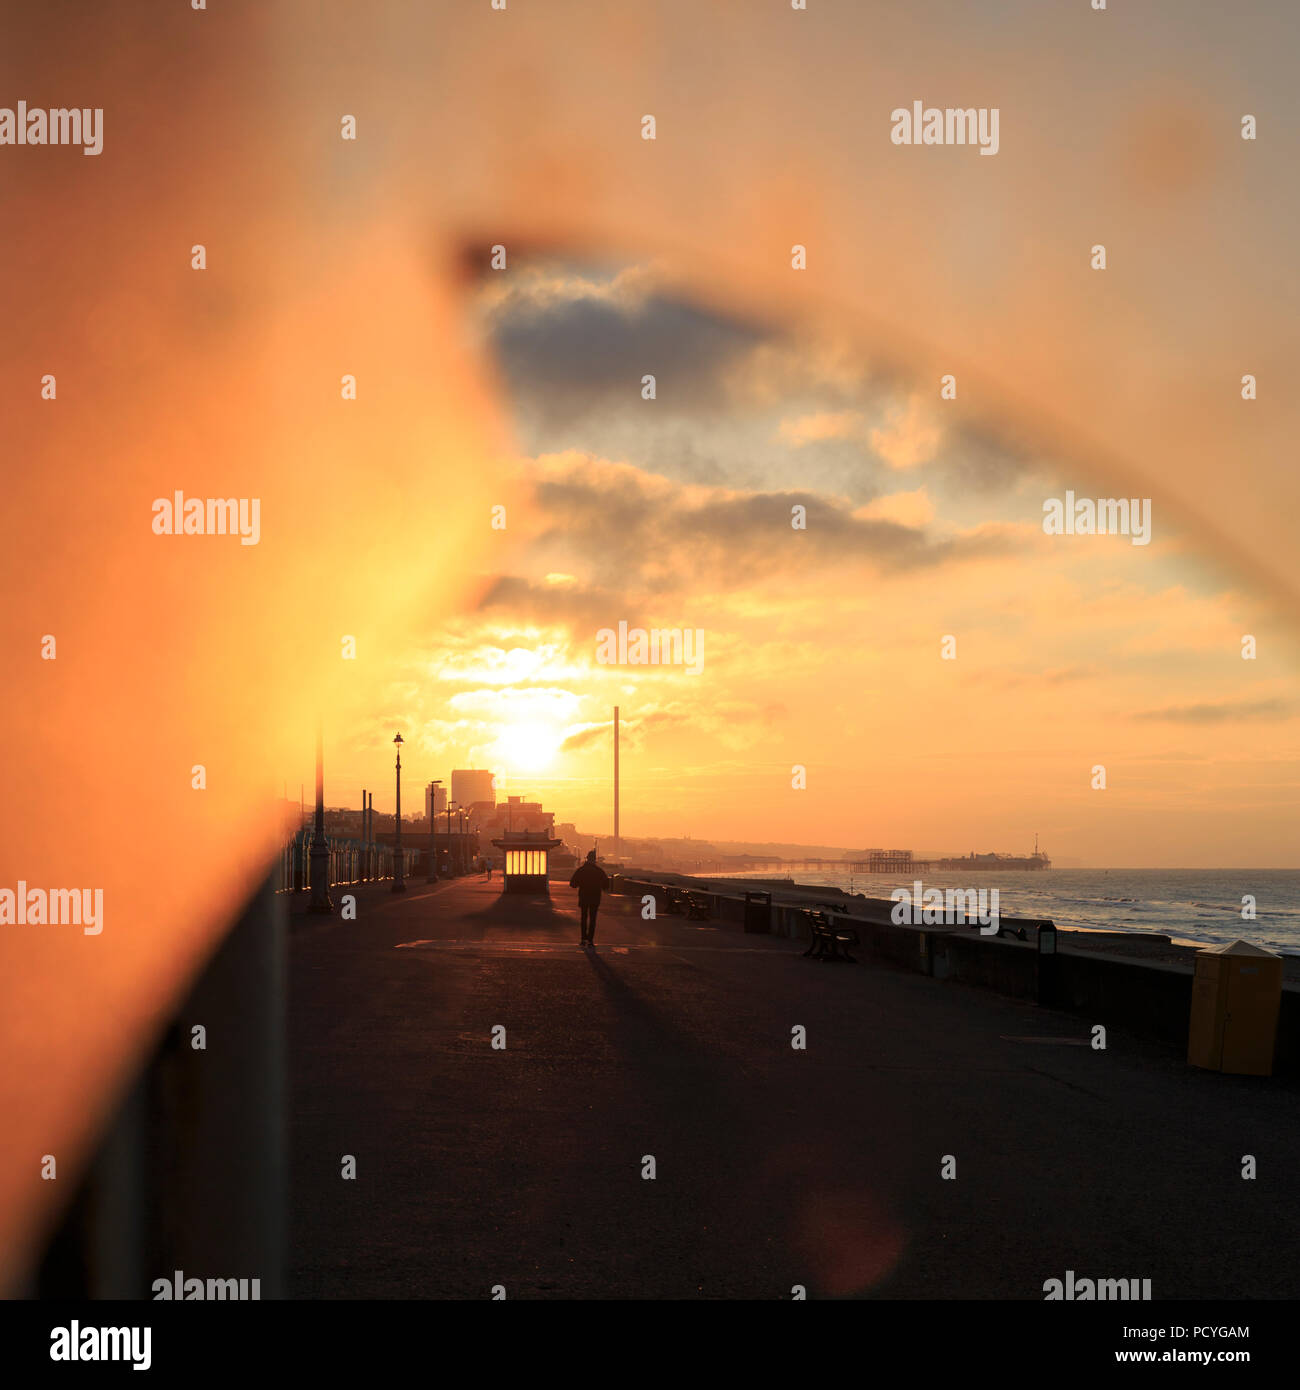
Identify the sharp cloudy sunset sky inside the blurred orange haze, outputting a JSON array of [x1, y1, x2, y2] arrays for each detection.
[[332, 261, 1297, 866]]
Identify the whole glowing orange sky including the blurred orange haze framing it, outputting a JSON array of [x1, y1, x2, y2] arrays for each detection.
[[0, 0, 1300, 1284]]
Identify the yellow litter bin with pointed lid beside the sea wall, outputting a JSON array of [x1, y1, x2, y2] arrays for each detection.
[[1187, 941, 1282, 1076]]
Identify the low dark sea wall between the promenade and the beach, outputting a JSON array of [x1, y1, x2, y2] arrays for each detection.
[[613, 874, 1300, 1076]]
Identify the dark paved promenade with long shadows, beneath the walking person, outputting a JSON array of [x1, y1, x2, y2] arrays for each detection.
[[288, 877, 1300, 1300]]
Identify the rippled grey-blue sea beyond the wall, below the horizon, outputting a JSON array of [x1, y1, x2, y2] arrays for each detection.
[[701, 866, 1300, 955]]
